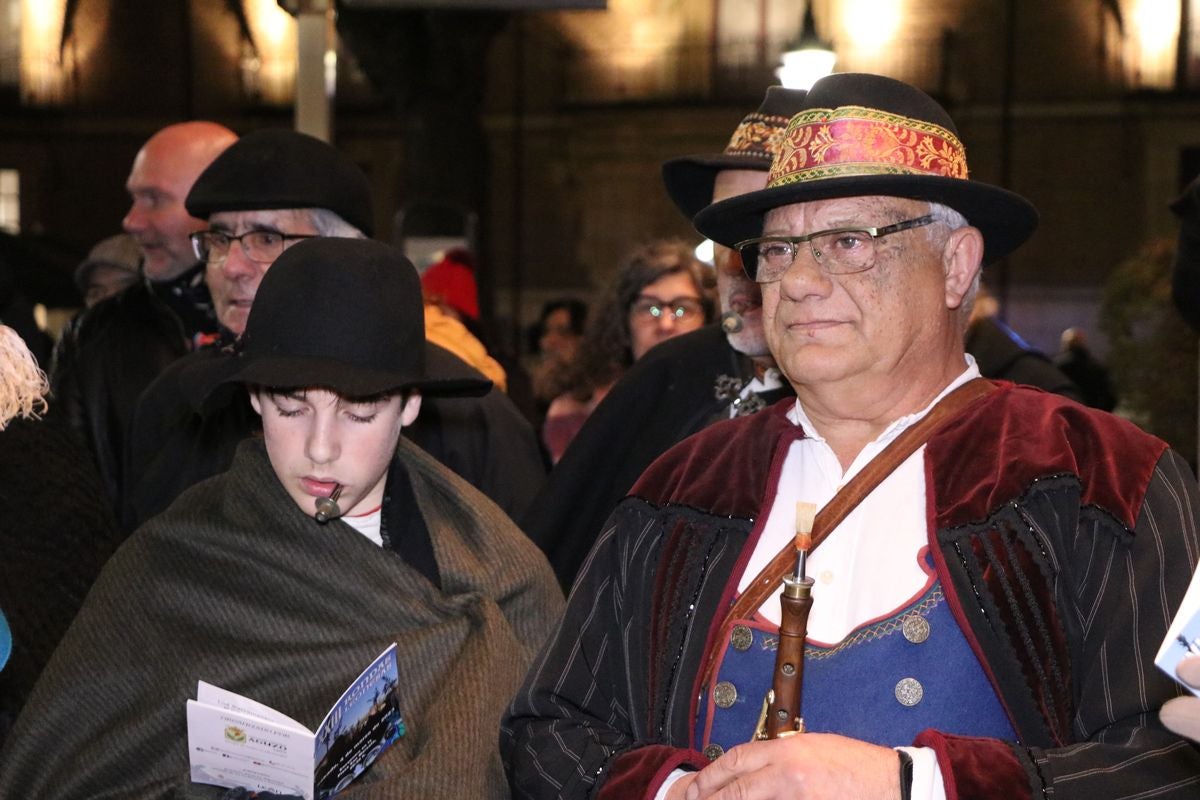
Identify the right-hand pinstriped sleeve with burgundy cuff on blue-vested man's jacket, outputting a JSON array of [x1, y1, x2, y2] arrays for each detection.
[[919, 451, 1200, 800]]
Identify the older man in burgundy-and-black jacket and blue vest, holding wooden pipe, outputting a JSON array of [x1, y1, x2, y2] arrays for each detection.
[[502, 74, 1200, 800]]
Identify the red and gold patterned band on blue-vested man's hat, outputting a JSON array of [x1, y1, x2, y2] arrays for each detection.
[[767, 106, 967, 187]]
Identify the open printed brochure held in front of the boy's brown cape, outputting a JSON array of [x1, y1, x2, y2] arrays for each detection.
[[187, 643, 404, 800]]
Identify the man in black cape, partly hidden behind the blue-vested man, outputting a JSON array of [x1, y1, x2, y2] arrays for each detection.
[[521, 86, 804, 588]]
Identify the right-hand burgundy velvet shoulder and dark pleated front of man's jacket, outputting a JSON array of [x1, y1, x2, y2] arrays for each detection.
[[925, 383, 1166, 746]]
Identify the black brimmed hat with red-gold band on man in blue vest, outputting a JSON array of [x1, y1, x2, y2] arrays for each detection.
[[694, 73, 1038, 264]]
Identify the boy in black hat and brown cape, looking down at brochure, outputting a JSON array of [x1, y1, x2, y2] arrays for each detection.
[[0, 239, 562, 799]]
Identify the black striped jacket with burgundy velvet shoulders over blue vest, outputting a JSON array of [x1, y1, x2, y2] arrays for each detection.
[[502, 384, 1200, 800]]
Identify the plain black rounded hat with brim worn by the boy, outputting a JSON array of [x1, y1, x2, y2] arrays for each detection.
[[188, 237, 492, 401]]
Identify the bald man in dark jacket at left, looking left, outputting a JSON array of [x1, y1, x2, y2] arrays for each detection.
[[50, 121, 238, 507]]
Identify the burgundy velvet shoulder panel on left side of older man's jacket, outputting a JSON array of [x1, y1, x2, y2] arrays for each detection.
[[629, 397, 796, 518]]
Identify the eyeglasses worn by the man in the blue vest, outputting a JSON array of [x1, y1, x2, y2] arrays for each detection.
[[733, 215, 935, 283]]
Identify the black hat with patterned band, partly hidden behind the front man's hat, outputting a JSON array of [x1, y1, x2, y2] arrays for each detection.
[[662, 86, 808, 219]]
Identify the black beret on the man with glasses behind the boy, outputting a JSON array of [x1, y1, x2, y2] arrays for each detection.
[[184, 128, 374, 236]]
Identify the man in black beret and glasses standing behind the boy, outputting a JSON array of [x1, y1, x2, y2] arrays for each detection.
[[121, 130, 545, 529]]
